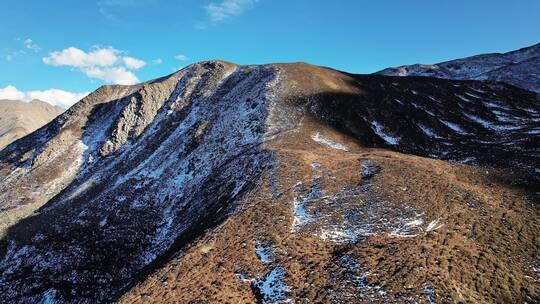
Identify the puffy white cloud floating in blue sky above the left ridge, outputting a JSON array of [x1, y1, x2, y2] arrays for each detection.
[[43, 47, 146, 85]]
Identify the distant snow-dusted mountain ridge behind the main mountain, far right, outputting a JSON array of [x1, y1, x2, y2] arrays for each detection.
[[377, 43, 540, 93]]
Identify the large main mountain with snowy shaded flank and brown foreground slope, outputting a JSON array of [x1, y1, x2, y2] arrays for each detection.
[[0, 61, 540, 303]]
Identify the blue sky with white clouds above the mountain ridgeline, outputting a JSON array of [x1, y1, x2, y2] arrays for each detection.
[[0, 0, 540, 106]]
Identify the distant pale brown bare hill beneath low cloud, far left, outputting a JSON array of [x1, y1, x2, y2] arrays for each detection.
[[0, 100, 64, 150]]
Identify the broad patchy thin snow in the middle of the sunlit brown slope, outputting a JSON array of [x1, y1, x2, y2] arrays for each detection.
[[291, 176, 424, 243]]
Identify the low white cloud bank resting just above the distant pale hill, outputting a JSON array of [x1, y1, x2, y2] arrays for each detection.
[[0, 85, 89, 108]]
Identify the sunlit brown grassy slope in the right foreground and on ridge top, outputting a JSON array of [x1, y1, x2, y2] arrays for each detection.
[[119, 64, 540, 303]]
